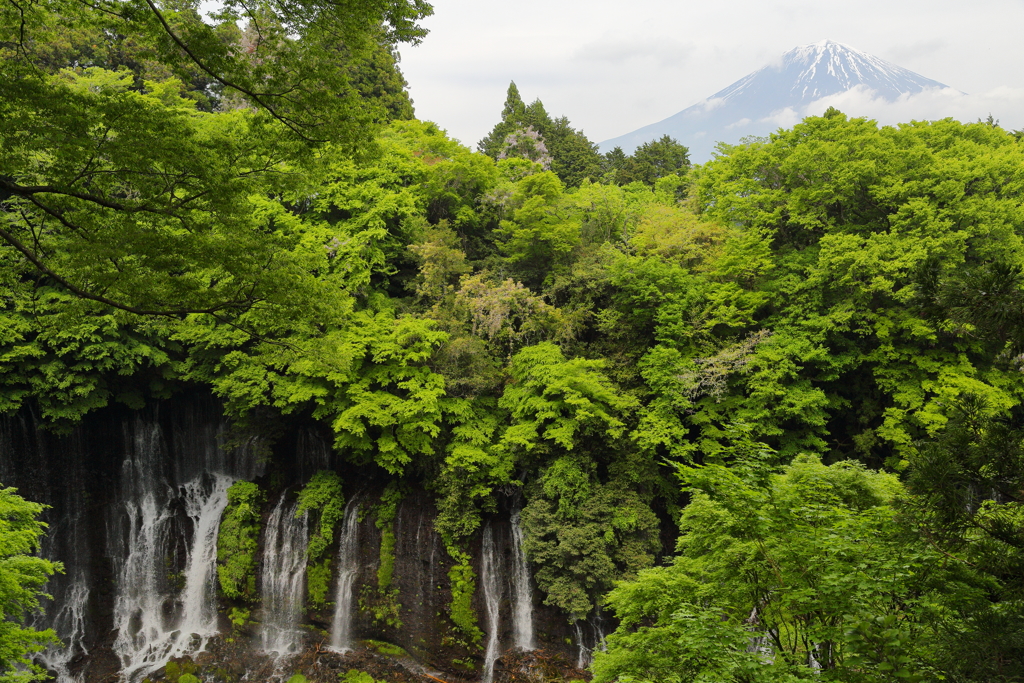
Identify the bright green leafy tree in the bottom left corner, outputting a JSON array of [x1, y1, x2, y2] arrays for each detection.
[[0, 487, 63, 683]]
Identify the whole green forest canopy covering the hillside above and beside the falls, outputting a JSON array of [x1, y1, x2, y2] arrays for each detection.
[[6, 0, 1024, 681]]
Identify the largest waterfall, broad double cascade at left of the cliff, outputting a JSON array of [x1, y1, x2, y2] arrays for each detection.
[[109, 414, 255, 681]]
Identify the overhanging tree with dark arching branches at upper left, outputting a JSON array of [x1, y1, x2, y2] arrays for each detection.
[[0, 0, 430, 317]]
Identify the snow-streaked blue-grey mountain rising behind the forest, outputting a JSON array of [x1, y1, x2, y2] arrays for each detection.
[[600, 40, 948, 163]]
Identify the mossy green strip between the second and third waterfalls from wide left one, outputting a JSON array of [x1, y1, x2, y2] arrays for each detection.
[[295, 470, 345, 609]]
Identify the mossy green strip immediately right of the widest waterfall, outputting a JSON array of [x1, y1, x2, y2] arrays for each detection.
[[217, 481, 263, 600]]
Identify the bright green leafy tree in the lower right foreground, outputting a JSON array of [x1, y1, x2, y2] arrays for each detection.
[[594, 450, 932, 682]]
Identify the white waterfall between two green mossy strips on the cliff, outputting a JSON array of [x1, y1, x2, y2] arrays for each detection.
[[260, 489, 309, 657]]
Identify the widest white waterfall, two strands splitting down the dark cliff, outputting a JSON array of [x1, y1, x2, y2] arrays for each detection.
[[112, 419, 233, 681]]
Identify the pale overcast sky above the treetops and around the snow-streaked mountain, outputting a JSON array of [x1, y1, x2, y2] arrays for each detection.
[[400, 0, 1024, 146]]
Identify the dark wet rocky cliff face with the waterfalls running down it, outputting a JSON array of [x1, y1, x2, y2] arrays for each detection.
[[0, 396, 602, 683]]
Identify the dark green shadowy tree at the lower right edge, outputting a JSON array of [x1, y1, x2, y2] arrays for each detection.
[[906, 395, 1024, 681]]
